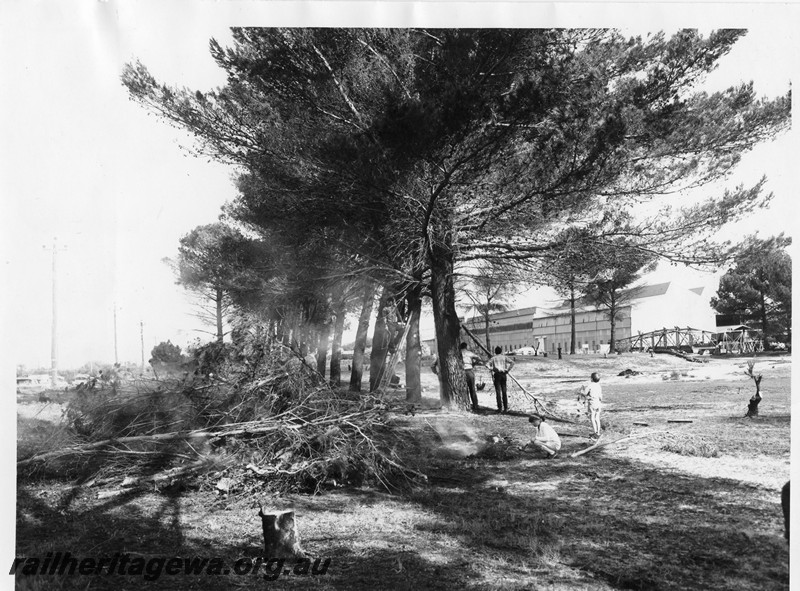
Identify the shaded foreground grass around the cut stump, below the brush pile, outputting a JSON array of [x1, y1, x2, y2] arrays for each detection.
[[17, 444, 789, 591]]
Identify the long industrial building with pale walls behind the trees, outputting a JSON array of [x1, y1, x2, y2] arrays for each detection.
[[456, 280, 716, 355]]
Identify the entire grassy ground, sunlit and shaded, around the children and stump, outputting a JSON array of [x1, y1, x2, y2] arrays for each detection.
[[17, 355, 791, 591]]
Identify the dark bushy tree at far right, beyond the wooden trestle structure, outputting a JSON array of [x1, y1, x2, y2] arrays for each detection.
[[711, 233, 792, 340]]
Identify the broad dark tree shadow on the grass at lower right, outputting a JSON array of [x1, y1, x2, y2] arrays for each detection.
[[404, 457, 789, 590]]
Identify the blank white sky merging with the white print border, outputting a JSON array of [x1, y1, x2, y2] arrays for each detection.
[[0, 0, 800, 368]]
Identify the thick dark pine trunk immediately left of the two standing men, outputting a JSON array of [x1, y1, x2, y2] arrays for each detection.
[[429, 242, 470, 408]]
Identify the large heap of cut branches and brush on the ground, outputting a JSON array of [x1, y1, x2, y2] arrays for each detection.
[[18, 339, 414, 493]]
